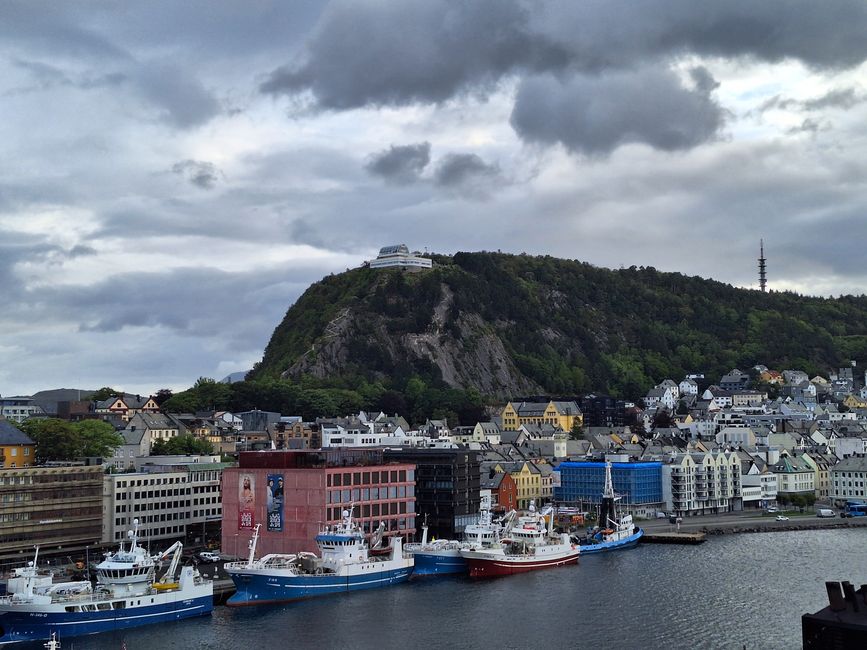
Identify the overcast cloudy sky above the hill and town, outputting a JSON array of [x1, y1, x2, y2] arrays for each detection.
[[0, 0, 867, 396]]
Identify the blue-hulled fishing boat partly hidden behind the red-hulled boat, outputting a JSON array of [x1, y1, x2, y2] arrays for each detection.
[[404, 496, 516, 576]]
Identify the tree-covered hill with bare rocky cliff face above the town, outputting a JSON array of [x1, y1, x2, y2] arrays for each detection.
[[250, 253, 867, 398]]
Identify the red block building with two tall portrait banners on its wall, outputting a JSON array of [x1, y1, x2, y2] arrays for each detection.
[[222, 449, 416, 557]]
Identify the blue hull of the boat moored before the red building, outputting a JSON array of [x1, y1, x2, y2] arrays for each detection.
[[226, 561, 413, 607]]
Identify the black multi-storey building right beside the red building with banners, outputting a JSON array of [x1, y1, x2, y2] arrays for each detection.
[[383, 448, 480, 539]]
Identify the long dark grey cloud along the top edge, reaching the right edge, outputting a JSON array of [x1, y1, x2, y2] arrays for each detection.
[[261, 0, 867, 110]]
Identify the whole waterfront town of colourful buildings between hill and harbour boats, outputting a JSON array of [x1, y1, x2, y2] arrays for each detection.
[[0, 361, 867, 566]]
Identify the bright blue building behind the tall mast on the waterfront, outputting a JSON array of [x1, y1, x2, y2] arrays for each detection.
[[554, 462, 662, 511]]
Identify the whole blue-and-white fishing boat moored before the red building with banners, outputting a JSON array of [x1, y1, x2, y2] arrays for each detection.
[[224, 509, 413, 607]]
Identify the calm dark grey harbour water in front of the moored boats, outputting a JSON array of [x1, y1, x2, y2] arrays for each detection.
[[18, 529, 867, 650]]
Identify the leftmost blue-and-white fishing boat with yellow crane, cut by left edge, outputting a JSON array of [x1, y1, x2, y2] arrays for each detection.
[[0, 519, 214, 644]]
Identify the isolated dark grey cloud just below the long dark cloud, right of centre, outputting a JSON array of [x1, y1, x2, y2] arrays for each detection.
[[511, 68, 724, 155]]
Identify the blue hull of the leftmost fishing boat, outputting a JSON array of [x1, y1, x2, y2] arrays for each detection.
[[0, 589, 214, 644]]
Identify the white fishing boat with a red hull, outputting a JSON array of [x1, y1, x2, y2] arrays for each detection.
[[461, 501, 581, 578]]
